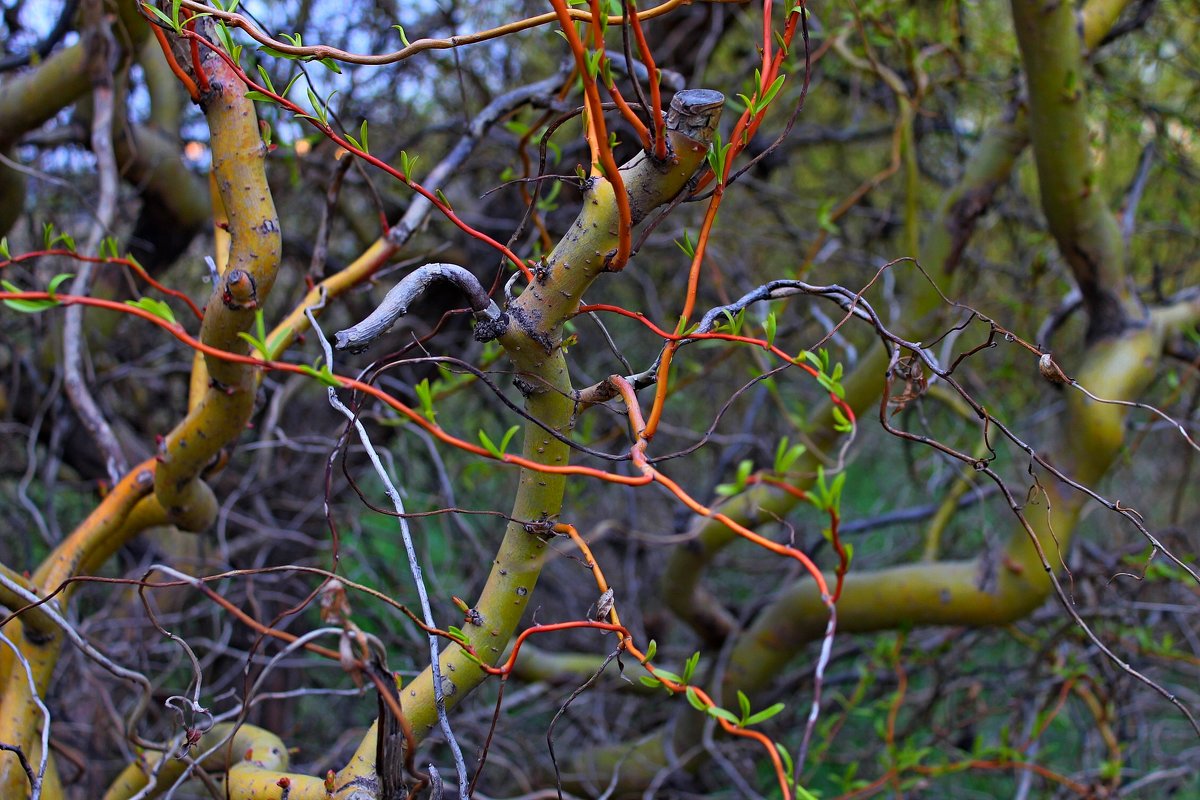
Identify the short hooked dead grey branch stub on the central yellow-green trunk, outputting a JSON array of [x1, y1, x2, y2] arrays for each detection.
[[334, 264, 509, 353]]
